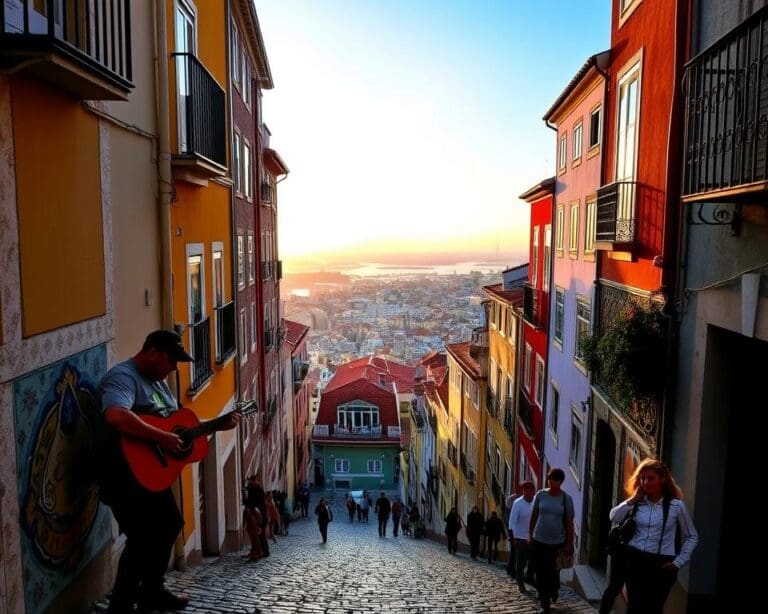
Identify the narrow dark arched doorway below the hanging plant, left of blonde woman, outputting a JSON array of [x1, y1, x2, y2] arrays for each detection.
[[589, 420, 616, 567]]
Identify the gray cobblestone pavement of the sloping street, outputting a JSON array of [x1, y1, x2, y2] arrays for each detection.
[[96, 493, 594, 614]]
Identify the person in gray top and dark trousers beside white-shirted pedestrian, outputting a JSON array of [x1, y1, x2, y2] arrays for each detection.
[[529, 468, 573, 614]]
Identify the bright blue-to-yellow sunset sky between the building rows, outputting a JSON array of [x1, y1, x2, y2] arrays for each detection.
[[255, 0, 610, 269]]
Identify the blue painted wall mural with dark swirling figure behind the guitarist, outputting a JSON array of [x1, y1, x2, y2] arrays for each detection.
[[13, 346, 111, 612]]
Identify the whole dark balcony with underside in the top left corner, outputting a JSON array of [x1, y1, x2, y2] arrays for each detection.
[[0, 0, 133, 100]]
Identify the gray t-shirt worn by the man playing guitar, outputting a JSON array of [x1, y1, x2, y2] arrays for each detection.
[[99, 359, 178, 416]]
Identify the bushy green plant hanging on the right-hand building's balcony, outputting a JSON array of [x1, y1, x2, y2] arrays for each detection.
[[582, 307, 667, 409]]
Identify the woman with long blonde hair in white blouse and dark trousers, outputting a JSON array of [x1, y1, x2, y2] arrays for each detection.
[[610, 458, 699, 614]]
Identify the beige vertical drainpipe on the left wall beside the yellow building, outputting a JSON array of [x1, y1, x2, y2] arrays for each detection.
[[154, 0, 187, 571]]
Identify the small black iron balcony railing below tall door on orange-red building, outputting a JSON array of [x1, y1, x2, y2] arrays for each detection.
[[595, 181, 637, 243]]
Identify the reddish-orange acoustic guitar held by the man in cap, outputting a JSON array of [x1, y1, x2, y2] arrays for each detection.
[[120, 401, 258, 492]]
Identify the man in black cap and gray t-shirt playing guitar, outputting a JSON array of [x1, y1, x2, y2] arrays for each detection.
[[98, 330, 241, 613]]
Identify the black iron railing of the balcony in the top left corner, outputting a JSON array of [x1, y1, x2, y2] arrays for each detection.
[[0, 0, 133, 99]]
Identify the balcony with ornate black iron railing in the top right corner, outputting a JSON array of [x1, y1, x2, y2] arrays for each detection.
[[683, 8, 768, 202]]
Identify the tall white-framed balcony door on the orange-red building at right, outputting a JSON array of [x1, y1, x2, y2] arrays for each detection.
[[616, 62, 640, 220]]
